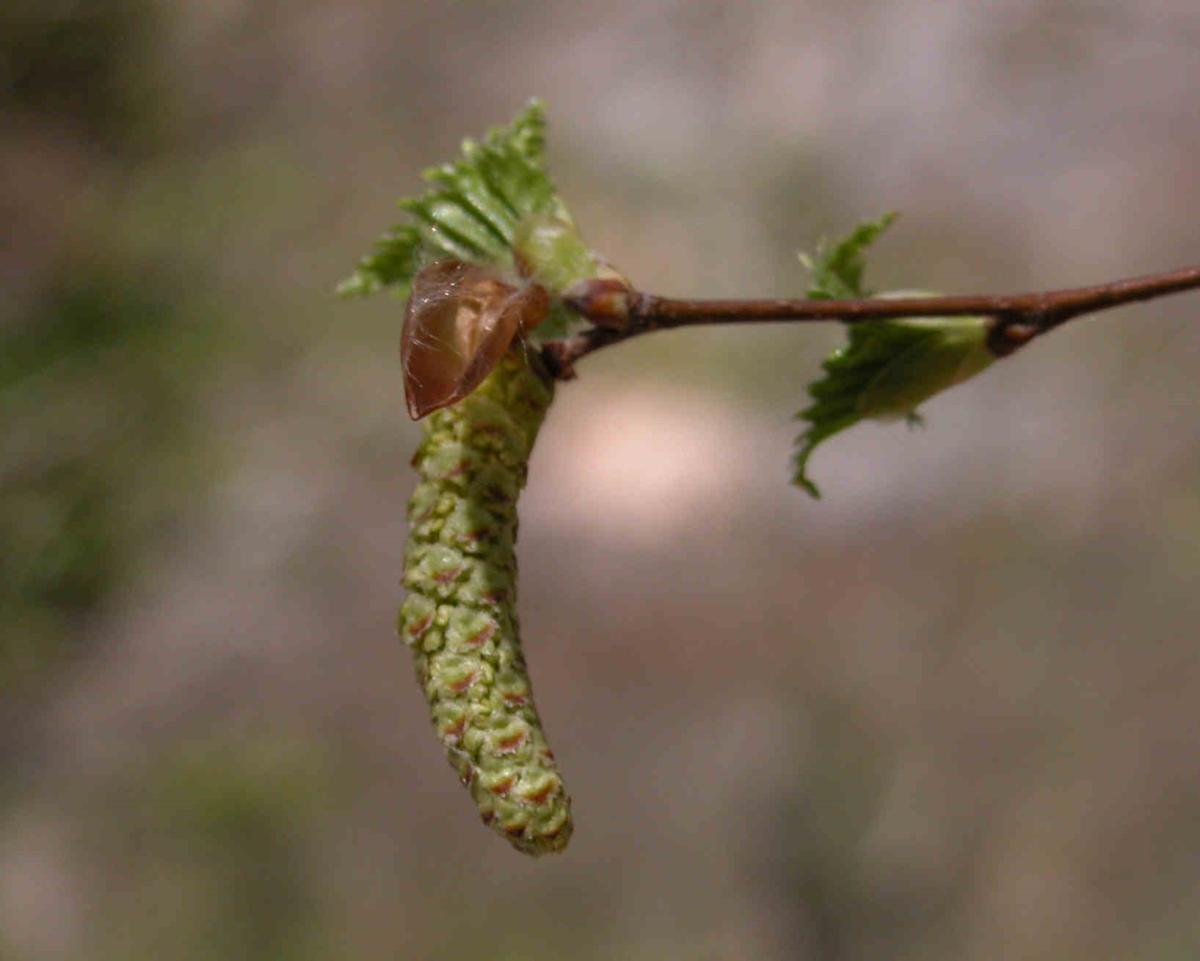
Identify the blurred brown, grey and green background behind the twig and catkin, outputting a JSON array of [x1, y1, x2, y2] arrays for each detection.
[[0, 0, 1200, 961]]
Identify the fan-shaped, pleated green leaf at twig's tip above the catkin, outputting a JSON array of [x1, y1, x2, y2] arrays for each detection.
[[337, 101, 601, 340]]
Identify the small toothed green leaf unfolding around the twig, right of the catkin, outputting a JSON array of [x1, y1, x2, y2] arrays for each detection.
[[792, 214, 995, 497]]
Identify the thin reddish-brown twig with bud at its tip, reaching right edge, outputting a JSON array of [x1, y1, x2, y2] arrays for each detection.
[[544, 266, 1200, 379]]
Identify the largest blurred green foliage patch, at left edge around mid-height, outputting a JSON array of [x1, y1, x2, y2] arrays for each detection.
[[0, 263, 215, 689]]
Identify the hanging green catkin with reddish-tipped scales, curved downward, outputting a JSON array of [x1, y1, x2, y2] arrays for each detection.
[[398, 343, 571, 855]]
